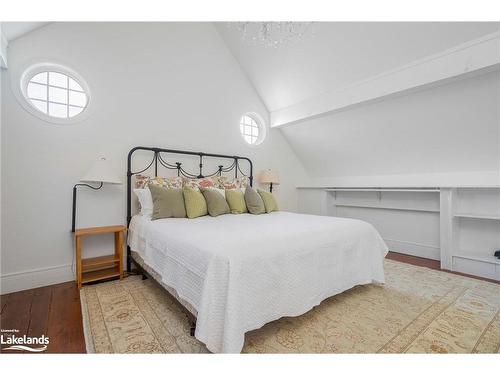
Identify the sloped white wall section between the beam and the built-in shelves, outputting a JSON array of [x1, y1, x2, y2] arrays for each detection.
[[282, 71, 500, 186]]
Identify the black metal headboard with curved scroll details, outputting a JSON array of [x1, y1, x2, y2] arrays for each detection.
[[127, 146, 253, 272]]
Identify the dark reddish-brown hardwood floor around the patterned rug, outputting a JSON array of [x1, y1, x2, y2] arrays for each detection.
[[0, 252, 500, 353]]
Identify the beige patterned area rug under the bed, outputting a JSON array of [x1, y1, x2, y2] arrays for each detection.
[[81, 260, 500, 353]]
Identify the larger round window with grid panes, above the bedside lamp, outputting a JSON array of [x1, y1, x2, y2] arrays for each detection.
[[21, 64, 90, 123]]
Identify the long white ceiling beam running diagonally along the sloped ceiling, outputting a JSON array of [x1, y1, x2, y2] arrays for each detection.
[[271, 31, 500, 127]]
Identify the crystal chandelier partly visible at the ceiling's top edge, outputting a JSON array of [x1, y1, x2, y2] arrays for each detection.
[[228, 21, 312, 48]]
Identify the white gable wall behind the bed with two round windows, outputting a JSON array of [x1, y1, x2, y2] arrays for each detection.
[[1, 23, 304, 293]]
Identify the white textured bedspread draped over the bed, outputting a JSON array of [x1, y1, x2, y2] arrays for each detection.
[[128, 212, 387, 353]]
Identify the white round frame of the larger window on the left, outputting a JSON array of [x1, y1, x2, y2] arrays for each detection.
[[19, 63, 93, 125]]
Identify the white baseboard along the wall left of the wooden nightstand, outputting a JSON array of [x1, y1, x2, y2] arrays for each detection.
[[0, 264, 75, 294]]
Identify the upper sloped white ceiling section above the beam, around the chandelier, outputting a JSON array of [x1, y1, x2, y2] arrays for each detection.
[[216, 22, 500, 112]]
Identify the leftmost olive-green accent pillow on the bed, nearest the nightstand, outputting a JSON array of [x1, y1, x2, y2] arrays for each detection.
[[148, 184, 186, 220]]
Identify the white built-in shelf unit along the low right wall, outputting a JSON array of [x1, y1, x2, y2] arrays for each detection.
[[299, 185, 500, 280]]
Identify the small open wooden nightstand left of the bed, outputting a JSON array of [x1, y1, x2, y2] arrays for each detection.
[[75, 225, 127, 289]]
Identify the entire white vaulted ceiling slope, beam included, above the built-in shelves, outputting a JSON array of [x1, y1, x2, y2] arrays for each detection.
[[216, 22, 500, 186]]
